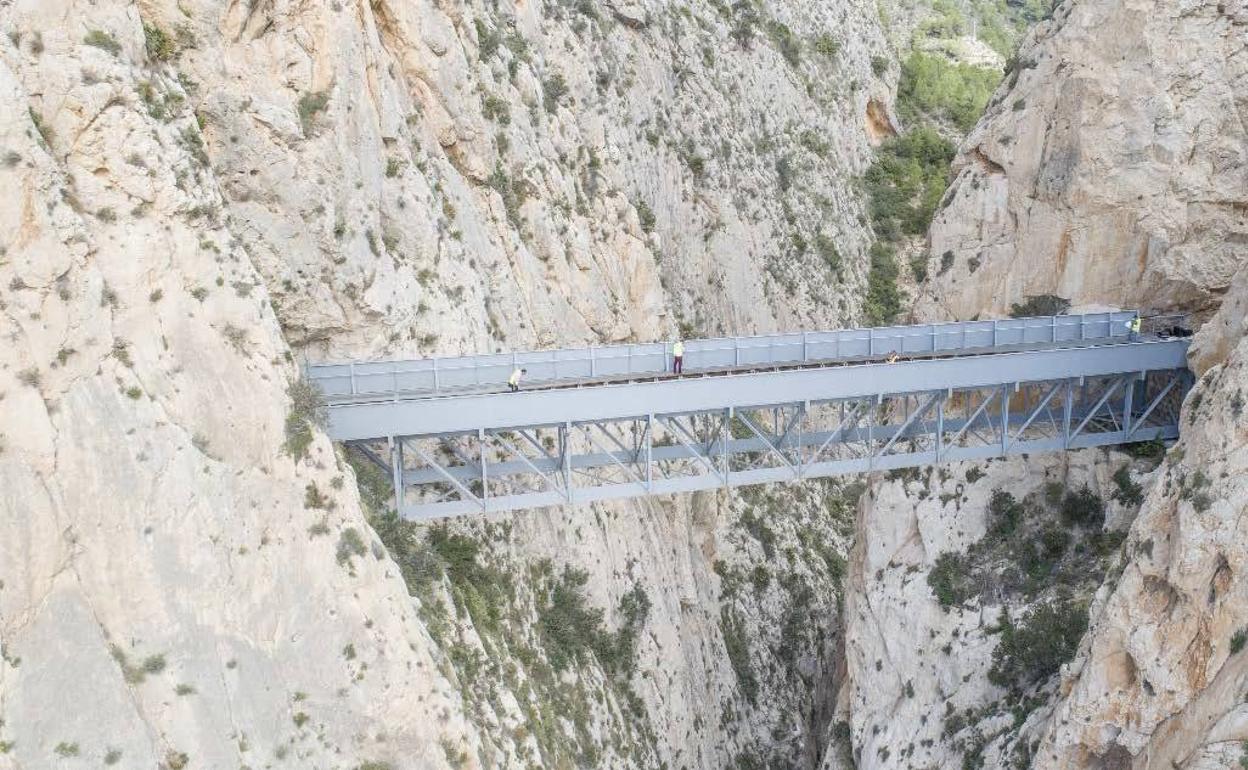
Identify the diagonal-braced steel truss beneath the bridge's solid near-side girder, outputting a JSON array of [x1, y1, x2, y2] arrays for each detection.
[[349, 369, 1191, 519]]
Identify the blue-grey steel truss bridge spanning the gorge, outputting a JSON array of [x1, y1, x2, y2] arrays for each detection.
[[306, 312, 1192, 519]]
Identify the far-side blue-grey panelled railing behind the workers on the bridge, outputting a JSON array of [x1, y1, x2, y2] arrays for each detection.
[[307, 311, 1137, 401]]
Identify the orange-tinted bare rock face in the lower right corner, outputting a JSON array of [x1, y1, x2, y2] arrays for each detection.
[[1037, 253, 1248, 769]]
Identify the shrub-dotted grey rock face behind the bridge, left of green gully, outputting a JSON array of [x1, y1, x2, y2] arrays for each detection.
[[163, 0, 890, 357]]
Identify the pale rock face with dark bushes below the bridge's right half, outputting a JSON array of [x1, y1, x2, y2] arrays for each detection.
[[825, 451, 1151, 770]]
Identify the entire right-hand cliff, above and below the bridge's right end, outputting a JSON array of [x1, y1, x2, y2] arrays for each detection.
[[846, 2, 1248, 768]]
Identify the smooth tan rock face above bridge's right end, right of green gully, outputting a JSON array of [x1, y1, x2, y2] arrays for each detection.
[[916, 0, 1248, 318]]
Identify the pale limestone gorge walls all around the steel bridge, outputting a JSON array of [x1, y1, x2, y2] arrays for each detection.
[[0, 0, 1248, 770]]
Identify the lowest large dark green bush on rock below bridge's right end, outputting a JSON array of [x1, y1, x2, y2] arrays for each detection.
[[988, 600, 1088, 691]]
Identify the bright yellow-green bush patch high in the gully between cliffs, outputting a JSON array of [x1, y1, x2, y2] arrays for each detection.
[[897, 51, 1001, 132]]
